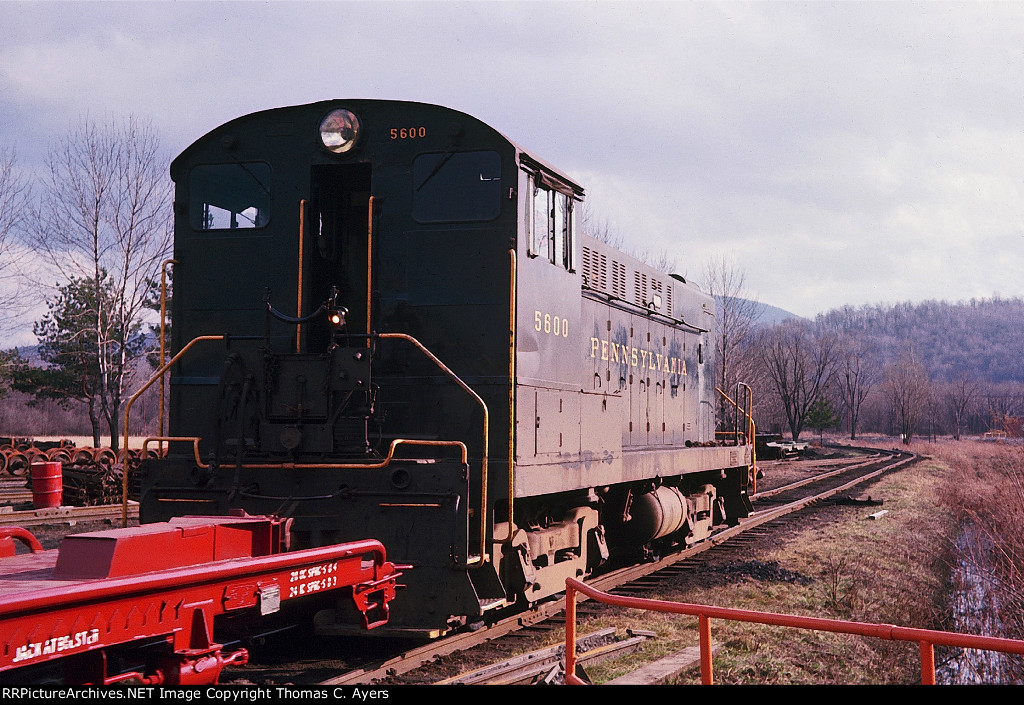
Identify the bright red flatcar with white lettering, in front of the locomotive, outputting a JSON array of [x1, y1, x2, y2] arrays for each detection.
[[0, 516, 400, 685]]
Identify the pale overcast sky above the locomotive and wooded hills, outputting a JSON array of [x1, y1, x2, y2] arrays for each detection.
[[0, 0, 1024, 346]]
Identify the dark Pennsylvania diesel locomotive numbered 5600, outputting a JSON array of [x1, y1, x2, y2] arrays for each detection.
[[139, 99, 754, 636]]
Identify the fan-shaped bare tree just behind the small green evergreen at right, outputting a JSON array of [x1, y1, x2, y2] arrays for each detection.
[[759, 320, 837, 441]]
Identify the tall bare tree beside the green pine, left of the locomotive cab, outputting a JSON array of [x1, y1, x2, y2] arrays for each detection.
[[33, 118, 171, 448]]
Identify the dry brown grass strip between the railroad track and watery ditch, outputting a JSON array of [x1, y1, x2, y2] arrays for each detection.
[[587, 446, 956, 683]]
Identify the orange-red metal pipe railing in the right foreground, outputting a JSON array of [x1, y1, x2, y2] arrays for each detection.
[[565, 578, 1024, 686]]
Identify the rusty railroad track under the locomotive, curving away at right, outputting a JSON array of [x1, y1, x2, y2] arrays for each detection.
[[286, 449, 916, 686]]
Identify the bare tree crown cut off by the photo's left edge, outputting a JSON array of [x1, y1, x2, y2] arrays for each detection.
[[0, 149, 30, 333]]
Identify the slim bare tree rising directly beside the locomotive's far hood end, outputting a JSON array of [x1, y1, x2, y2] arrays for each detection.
[[703, 257, 761, 422]]
